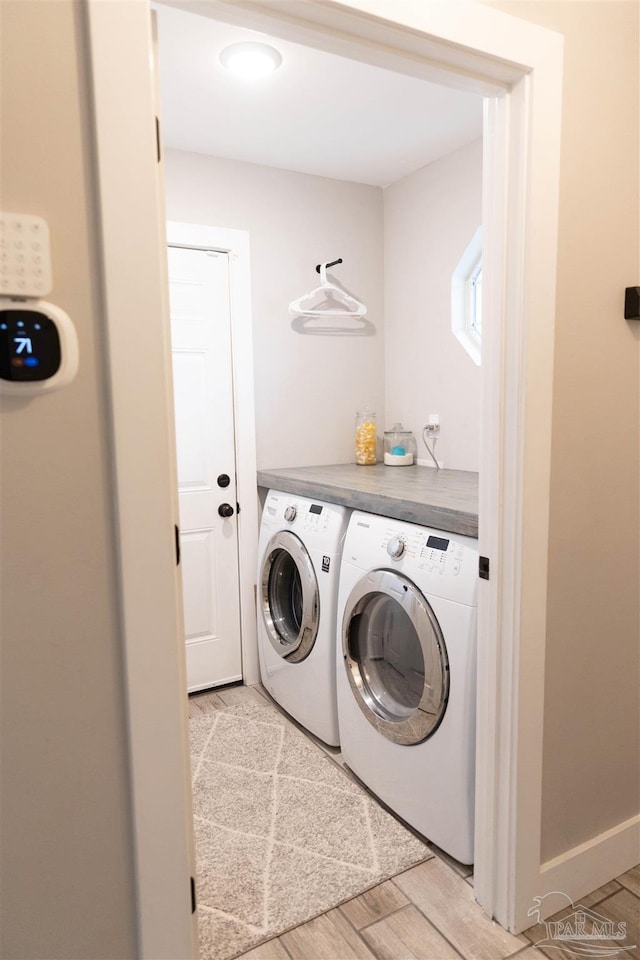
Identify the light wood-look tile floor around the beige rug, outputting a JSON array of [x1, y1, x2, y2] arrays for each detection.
[[189, 687, 640, 960]]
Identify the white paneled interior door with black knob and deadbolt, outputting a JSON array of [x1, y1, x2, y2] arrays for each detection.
[[168, 240, 242, 691]]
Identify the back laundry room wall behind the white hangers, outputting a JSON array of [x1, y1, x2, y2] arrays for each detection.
[[165, 150, 384, 469]]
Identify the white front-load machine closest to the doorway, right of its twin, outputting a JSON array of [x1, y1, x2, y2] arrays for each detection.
[[337, 512, 478, 863]]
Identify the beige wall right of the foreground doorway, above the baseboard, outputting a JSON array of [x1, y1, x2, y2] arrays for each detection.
[[482, 0, 640, 861]]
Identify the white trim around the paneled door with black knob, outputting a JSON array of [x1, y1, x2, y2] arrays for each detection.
[[166, 220, 260, 683]]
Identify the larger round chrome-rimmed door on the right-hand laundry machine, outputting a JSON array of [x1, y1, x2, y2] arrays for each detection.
[[342, 570, 449, 745]]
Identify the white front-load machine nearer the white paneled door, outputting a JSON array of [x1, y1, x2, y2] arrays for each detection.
[[258, 490, 351, 746]]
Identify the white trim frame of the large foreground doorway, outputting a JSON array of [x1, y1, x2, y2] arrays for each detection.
[[85, 0, 564, 958]]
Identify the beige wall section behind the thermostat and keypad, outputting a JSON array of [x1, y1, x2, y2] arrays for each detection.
[[0, 0, 136, 960]]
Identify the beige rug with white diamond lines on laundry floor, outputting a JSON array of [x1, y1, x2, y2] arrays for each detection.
[[190, 687, 433, 960]]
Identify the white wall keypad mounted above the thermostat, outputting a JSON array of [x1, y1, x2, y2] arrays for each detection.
[[0, 213, 52, 297]]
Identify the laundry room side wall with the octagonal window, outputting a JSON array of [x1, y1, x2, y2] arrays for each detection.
[[384, 140, 482, 470]]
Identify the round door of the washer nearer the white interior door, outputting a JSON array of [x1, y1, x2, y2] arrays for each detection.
[[260, 530, 320, 663]]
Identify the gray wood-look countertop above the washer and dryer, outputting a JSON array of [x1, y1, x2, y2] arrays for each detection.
[[258, 463, 478, 537]]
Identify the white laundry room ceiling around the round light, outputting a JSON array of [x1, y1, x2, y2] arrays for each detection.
[[156, 6, 482, 187]]
